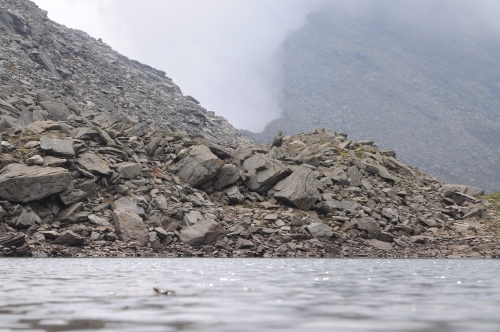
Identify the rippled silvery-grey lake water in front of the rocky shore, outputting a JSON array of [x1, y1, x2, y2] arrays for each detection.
[[0, 258, 500, 332]]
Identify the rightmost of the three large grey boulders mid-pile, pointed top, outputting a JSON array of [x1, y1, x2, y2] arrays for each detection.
[[274, 166, 320, 211]]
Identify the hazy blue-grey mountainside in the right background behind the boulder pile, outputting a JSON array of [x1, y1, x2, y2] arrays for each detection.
[[250, 13, 500, 191]]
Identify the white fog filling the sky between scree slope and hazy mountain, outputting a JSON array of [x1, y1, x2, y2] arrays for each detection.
[[35, 0, 500, 132]]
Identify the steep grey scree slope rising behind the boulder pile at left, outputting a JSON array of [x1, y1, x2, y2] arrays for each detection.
[[0, 0, 248, 143]]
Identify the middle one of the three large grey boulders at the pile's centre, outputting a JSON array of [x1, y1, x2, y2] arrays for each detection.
[[242, 153, 290, 193]]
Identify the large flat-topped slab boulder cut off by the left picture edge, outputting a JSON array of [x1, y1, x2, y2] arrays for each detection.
[[0, 164, 71, 203]]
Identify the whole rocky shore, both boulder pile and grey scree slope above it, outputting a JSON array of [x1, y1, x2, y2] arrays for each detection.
[[0, 0, 500, 258]]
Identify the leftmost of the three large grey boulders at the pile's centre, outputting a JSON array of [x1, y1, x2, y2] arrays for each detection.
[[177, 145, 223, 187]]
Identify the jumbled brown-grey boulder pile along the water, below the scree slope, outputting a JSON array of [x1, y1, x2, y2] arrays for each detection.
[[0, 118, 500, 257]]
